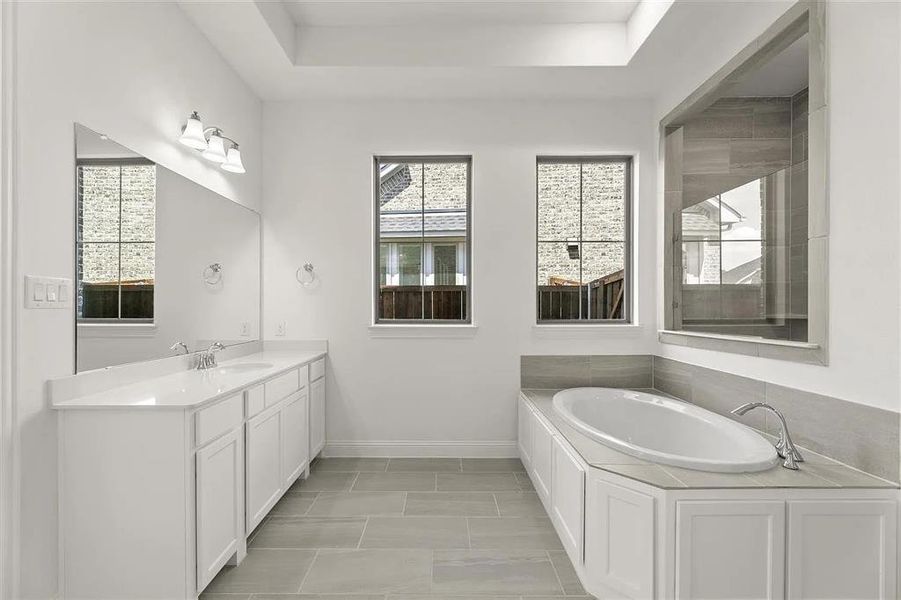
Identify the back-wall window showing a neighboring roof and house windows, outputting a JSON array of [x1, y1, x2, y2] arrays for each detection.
[[374, 157, 472, 323]]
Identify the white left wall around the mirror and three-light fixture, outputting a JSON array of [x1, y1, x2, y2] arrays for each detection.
[[14, 2, 261, 598]]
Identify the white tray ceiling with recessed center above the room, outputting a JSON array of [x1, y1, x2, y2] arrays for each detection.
[[179, 0, 794, 102]]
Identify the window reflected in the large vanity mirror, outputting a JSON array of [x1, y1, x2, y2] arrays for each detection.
[[76, 159, 156, 321]]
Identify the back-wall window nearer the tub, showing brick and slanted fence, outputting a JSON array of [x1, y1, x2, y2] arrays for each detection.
[[537, 156, 632, 322]]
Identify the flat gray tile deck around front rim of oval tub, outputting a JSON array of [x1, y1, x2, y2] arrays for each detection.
[[521, 389, 898, 489]]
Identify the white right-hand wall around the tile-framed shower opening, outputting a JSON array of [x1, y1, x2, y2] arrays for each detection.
[[658, 2, 901, 411]]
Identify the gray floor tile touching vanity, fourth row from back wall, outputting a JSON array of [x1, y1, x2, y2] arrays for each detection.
[[251, 517, 366, 548]]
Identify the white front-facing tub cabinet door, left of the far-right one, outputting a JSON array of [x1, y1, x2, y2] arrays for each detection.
[[676, 500, 785, 600]]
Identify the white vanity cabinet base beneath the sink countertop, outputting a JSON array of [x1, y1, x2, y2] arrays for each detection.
[[59, 354, 324, 600]]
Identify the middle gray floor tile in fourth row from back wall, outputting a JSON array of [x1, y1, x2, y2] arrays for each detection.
[[360, 517, 469, 548]]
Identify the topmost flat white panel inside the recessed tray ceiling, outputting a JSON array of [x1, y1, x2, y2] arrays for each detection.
[[283, 0, 638, 27]]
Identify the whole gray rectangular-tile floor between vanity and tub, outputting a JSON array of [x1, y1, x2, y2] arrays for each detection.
[[201, 458, 585, 600]]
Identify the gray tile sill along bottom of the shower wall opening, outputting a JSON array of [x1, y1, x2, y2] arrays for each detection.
[[657, 329, 828, 365]]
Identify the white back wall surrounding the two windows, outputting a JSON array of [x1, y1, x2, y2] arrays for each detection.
[[263, 100, 656, 450]]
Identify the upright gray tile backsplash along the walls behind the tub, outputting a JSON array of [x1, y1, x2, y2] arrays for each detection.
[[520, 355, 901, 482]]
